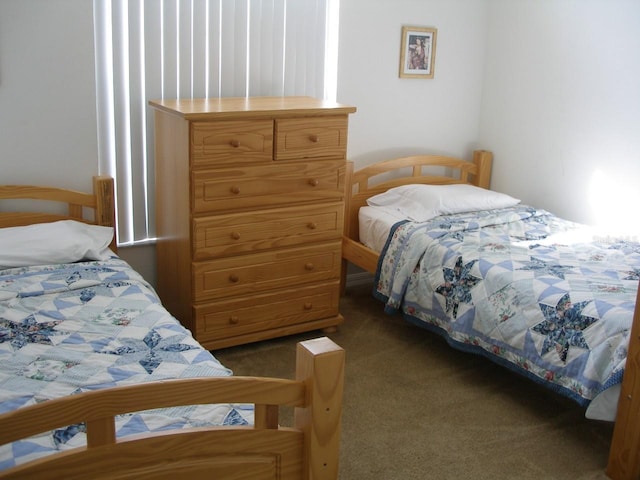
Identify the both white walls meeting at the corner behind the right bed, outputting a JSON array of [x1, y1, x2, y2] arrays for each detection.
[[338, 0, 640, 232]]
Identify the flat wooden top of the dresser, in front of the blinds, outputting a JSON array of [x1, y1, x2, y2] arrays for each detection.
[[149, 97, 356, 120]]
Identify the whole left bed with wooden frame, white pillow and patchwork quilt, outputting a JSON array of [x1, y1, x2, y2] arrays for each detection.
[[0, 178, 343, 479]]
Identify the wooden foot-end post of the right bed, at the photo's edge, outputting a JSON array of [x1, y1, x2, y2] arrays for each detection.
[[607, 282, 640, 480]]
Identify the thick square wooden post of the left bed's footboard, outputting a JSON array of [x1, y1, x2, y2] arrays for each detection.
[[294, 337, 345, 480]]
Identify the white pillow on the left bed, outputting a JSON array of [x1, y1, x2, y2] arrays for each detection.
[[0, 220, 113, 268]]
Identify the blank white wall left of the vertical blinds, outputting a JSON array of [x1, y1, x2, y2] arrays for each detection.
[[0, 0, 98, 191]]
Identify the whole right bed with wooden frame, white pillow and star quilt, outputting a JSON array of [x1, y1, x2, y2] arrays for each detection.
[[343, 151, 640, 478]]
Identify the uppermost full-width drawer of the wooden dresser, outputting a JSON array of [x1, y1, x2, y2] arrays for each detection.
[[192, 160, 345, 214]]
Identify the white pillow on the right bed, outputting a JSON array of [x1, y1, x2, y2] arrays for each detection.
[[367, 184, 520, 222]]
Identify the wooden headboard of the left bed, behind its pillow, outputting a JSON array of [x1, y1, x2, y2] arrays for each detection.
[[0, 176, 117, 252]]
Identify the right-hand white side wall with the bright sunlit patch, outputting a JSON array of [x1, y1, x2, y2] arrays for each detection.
[[480, 0, 640, 231]]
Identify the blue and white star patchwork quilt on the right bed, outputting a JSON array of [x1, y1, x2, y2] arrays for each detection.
[[374, 205, 640, 406]]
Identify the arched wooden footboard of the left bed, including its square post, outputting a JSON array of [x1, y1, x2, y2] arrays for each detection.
[[0, 337, 345, 480]]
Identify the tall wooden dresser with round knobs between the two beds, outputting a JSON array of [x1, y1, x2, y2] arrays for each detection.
[[150, 97, 355, 349]]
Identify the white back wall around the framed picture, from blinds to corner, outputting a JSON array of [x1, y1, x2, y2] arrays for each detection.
[[338, 0, 487, 167]]
